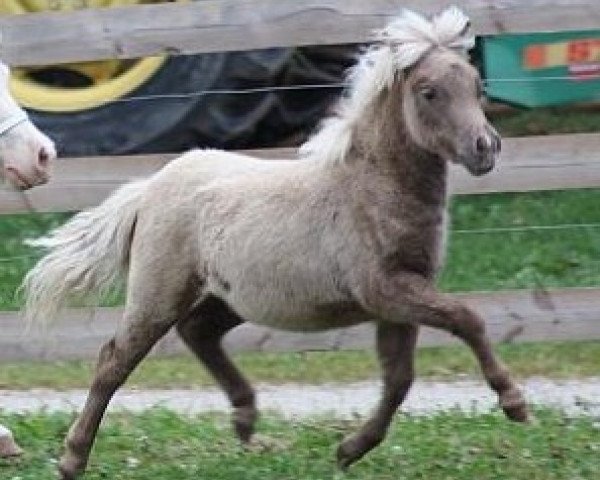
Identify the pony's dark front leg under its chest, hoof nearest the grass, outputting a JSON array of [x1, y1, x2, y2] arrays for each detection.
[[337, 323, 418, 469]]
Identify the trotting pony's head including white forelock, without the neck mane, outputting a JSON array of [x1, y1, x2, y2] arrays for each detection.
[[382, 8, 501, 175]]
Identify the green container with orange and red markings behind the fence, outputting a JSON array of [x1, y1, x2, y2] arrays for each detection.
[[481, 30, 600, 107]]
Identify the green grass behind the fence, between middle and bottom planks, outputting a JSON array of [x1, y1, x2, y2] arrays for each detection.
[[0, 189, 600, 310]]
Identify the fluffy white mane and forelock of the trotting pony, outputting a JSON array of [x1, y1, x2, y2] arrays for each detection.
[[300, 7, 474, 162]]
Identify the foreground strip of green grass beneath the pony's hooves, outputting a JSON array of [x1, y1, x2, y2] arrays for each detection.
[[0, 410, 600, 480]]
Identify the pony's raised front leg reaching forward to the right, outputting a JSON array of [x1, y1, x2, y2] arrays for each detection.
[[363, 274, 528, 422]]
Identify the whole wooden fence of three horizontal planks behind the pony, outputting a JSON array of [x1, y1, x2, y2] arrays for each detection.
[[0, 0, 600, 359]]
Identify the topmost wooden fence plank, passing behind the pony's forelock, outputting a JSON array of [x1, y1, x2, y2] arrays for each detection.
[[0, 0, 600, 65]]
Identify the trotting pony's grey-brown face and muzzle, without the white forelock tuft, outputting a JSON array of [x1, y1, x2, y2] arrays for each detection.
[[403, 47, 501, 175]]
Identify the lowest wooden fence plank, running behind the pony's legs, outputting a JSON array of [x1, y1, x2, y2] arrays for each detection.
[[0, 288, 600, 361]]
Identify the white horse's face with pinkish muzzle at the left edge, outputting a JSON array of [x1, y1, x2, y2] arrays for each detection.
[[0, 62, 56, 189]]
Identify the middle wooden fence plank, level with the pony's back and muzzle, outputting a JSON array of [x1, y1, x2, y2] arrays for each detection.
[[0, 133, 600, 214]]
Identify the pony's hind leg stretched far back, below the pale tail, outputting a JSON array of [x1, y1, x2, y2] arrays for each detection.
[[58, 269, 197, 480]]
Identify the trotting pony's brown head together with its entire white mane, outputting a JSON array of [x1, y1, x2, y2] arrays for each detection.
[[300, 7, 500, 175]]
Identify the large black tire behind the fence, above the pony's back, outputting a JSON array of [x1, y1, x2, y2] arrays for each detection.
[[31, 47, 354, 156]]
